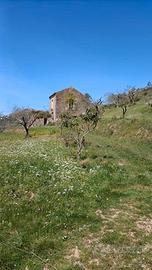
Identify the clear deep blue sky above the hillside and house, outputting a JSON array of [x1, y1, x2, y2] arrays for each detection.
[[0, 0, 152, 114]]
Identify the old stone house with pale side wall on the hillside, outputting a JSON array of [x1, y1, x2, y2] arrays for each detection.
[[49, 87, 91, 121]]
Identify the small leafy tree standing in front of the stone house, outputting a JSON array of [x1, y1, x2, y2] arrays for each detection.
[[61, 104, 100, 160]]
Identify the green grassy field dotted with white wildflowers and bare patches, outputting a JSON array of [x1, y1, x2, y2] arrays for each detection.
[[0, 103, 152, 270]]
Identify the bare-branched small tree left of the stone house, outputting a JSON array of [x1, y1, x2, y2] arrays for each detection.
[[10, 108, 40, 138]]
